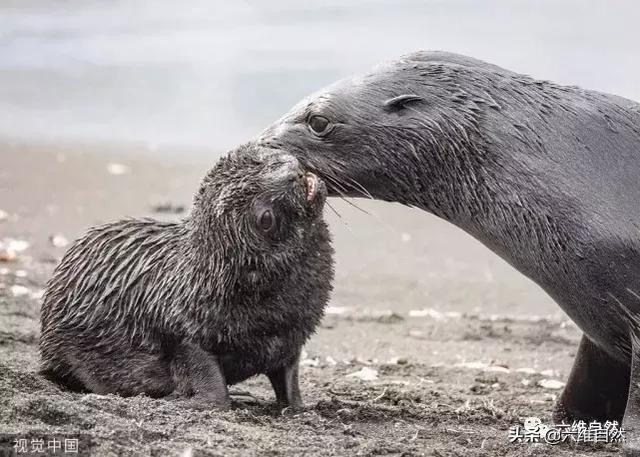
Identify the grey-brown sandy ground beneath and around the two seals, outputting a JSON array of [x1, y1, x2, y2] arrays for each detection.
[[0, 145, 618, 456]]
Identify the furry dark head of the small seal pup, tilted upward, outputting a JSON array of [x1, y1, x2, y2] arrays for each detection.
[[188, 144, 327, 278]]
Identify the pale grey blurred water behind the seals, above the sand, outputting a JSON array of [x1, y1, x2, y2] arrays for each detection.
[[0, 0, 640, 158]]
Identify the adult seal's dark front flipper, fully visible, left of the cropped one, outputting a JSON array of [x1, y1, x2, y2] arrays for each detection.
[[553, 335, 629, 424]]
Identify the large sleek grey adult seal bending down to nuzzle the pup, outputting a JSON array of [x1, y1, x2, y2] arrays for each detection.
[[259, 52, 640, 448]]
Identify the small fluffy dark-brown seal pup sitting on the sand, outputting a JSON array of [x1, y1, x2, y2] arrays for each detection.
[[40, 146, 333, 408]]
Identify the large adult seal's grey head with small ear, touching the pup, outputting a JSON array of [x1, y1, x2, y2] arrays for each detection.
[[258, 52, 497, 215]]
